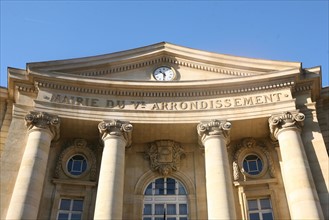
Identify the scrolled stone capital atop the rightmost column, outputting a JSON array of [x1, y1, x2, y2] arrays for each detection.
[[268, 112, 305, 140]]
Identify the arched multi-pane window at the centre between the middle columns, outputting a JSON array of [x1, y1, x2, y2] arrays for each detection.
[[143, 177, 188, 220]]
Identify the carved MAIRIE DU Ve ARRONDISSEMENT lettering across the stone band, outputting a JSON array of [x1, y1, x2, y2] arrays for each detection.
[[44, 92, 290, 111]]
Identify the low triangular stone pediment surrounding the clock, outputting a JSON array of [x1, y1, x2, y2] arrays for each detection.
[[27, 42, 301, 81]]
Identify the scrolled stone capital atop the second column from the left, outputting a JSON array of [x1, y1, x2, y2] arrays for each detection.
[[98, 120, 133, 147]]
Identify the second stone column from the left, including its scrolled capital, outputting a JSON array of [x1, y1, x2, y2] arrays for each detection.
[[94, 120, 133, 219]]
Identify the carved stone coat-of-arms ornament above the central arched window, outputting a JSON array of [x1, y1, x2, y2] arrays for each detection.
[[145, 140, 185, 176]]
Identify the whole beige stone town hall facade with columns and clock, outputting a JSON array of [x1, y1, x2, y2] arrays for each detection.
[[0, 42, 329, 220]]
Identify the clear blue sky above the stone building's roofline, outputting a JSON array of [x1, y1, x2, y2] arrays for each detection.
[[0, 0, 329, 87]]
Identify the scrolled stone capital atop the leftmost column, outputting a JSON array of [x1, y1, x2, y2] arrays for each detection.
[[25, 111, 60, 141]]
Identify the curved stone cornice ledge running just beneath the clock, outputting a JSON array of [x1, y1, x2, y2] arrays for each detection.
[[29, 66, 300, 90]]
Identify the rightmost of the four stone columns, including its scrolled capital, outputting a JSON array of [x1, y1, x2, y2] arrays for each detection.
[[269, 112, 324, 219]]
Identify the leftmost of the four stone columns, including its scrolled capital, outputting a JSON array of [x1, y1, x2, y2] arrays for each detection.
[[6, 112, 59, 219]]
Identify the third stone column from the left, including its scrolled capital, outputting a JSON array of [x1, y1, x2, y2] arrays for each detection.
[[197, 120, 236, 219]]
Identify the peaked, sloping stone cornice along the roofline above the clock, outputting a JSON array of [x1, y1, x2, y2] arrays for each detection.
[[27, 42, 301, 77]]
